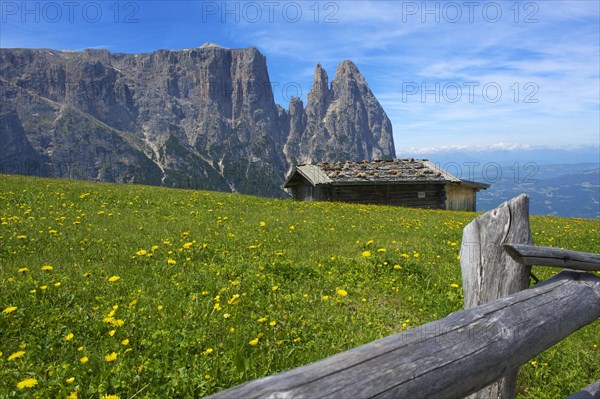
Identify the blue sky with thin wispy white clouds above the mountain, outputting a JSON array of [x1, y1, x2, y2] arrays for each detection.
[[0, 0, 600, 156]]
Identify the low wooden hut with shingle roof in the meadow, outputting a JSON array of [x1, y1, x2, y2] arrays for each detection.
[[284, 158, 489, 211]]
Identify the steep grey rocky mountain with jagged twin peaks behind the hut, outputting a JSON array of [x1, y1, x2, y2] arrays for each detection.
[[0, 44, 394, 196]]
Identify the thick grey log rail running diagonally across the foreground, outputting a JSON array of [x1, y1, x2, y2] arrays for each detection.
[[209, 271, 600, 399]]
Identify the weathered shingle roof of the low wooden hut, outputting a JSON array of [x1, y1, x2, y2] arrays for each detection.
[[285, 158, 489, 188]]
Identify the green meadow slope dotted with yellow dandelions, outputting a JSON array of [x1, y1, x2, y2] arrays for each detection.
[[0, 176, 600, 398]]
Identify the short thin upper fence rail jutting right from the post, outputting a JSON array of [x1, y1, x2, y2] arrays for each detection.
[[504, 244, 600, 272]]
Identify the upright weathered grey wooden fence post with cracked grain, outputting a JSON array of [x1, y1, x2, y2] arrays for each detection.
[[460, 194, 533, 399]]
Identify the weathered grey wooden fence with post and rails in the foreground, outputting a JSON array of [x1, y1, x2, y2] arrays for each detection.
[[209, 195, 600, 399]]
